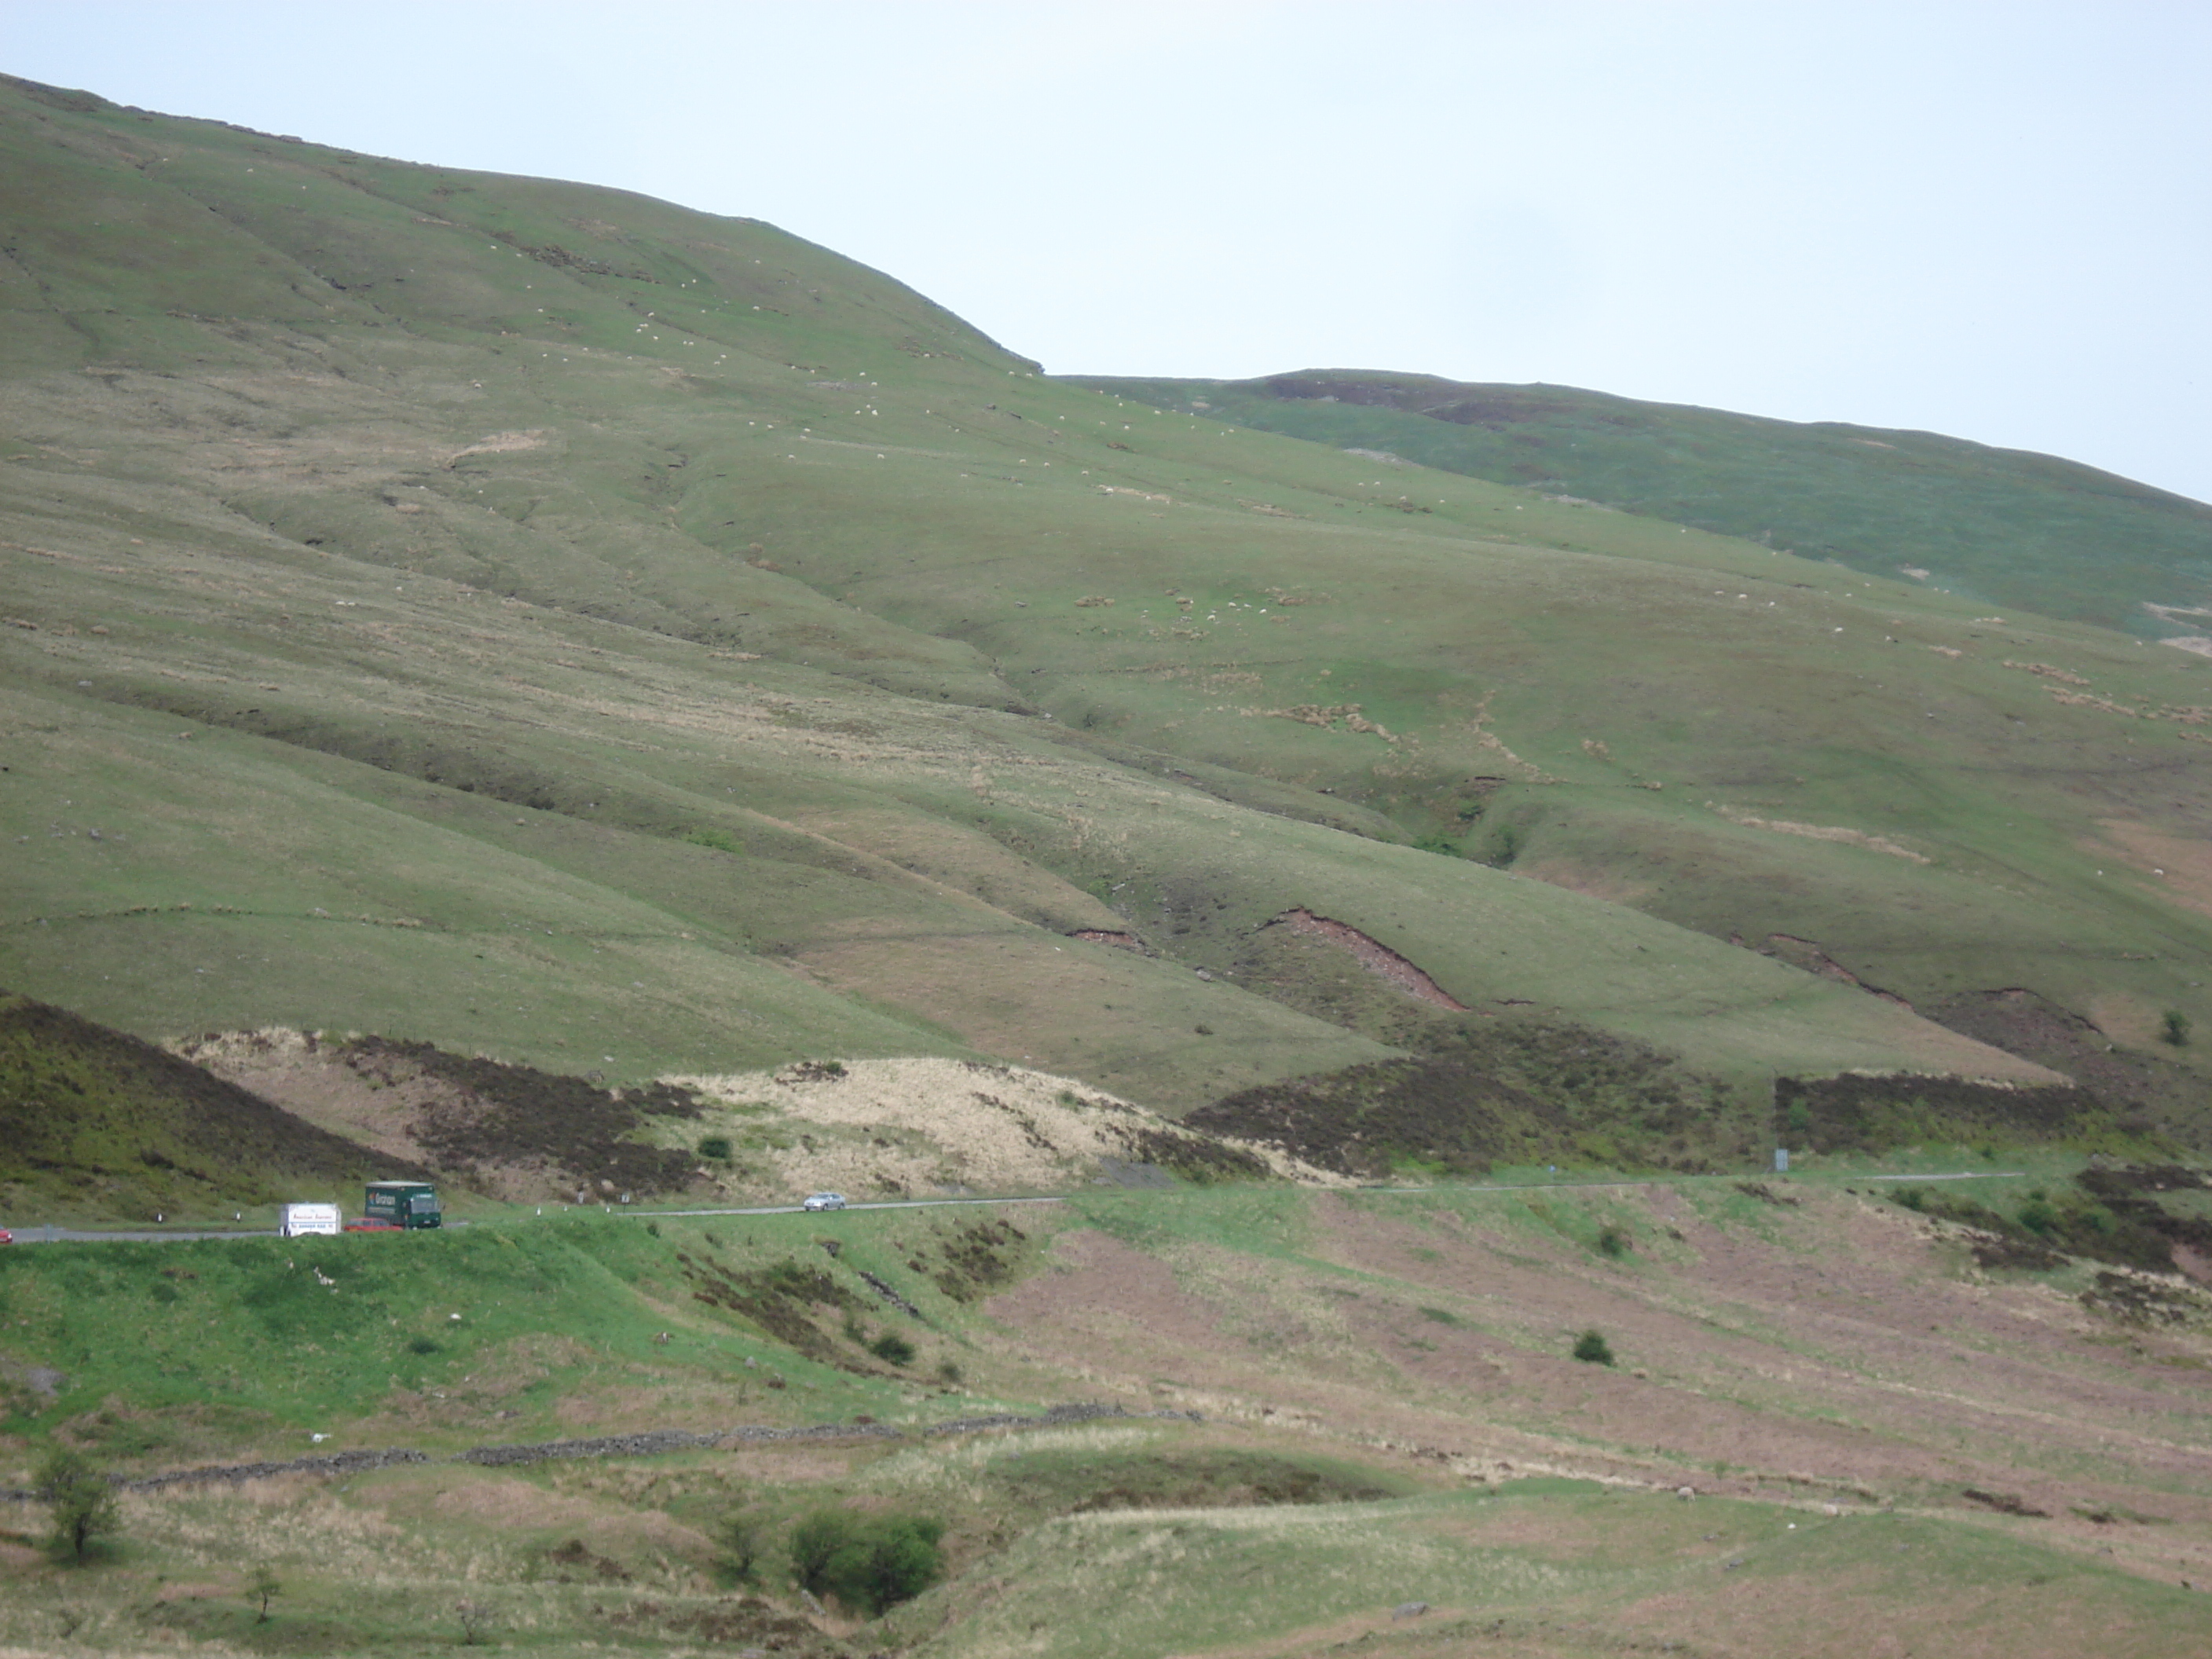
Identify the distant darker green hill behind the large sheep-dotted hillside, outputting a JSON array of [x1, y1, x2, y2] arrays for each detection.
[[1075, 369, 2212, 639]]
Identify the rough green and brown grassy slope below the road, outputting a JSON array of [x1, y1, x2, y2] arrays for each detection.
[[0, 1172, 2212, 1659]]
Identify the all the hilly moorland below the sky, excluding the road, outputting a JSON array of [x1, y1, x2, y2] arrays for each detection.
[[0, 79, 2212, 1659]]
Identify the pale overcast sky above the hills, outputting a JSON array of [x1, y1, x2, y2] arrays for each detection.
[[13, 0, 2212, 500]]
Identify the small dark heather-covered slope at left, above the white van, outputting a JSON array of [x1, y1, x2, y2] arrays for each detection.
[[0, 993, 427, 1219]]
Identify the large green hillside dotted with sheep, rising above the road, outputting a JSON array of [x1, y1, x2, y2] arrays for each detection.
[[0, 71, 2212, 1159]]
